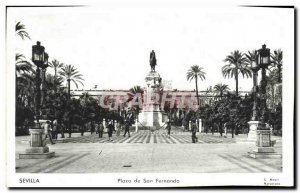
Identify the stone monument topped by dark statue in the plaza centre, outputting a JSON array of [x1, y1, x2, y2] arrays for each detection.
[[139, 50, 163, 130]]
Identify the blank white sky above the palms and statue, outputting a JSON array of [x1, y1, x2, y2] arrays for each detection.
[[8, 6, 293, 91]]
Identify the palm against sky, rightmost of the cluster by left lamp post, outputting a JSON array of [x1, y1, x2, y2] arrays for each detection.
[[59, 65, 84, 99]]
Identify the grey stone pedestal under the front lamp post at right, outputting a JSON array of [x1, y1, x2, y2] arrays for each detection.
[[249, 130, 281, 159]]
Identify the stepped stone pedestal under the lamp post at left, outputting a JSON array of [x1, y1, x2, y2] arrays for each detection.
[[19, 121, 55, 159]]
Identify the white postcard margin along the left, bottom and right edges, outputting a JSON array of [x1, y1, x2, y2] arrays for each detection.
[[1, 1, 294, 187]]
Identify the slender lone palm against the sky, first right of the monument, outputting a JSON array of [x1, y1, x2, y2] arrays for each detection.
[[186, 65, 206, 106]]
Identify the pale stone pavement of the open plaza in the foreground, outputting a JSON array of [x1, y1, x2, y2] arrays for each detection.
[[16, 132, 282, 173]]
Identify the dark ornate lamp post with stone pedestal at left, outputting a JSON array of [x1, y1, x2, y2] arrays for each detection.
[[19, 41, 54, 159]]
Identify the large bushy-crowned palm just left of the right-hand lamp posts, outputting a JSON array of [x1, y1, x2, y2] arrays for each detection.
[[222, 50, 252, 96]]
